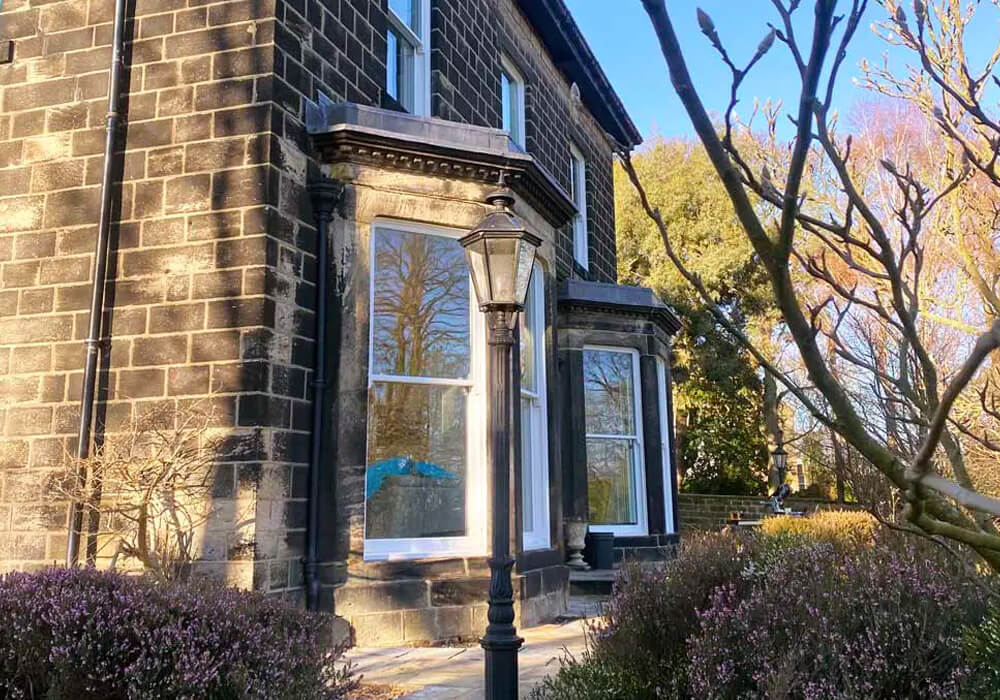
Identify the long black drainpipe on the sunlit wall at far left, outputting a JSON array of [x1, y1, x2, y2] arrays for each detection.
[[66, 0, 125, 566]]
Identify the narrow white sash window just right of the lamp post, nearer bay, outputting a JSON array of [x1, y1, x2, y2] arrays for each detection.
[[521, 263, 549, 550]]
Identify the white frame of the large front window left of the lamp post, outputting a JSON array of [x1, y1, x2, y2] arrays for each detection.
[[364, 219, 487, 561]]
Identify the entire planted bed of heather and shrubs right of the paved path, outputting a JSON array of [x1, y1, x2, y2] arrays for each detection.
[[534, 512, 1000, 700]]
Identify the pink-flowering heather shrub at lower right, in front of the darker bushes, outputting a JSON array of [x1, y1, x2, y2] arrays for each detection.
[[688, 542, 985, 700]]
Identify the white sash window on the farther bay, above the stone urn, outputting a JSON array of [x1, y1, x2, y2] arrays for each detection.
[[583, 346, 648, 536]]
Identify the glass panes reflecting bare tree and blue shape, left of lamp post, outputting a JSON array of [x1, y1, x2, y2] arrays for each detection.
[[366, 231, 470, 538]]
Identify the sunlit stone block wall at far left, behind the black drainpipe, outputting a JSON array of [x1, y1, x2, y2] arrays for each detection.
[[0, 0, 328, 592]]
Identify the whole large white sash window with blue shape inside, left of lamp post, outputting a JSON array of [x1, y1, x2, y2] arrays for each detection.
[[365, 223, 486, 559]]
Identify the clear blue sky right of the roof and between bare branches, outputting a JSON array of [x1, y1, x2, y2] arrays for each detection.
[[566, 0, 1000, 141]]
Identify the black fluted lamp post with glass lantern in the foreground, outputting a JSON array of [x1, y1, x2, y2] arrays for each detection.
[[460, 190, 542, 700]]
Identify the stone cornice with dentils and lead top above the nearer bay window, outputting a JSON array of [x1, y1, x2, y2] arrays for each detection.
[[310, 105, 576, 227]]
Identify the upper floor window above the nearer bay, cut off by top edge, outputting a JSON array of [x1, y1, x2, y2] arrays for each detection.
[[385, 0, 431, 116]]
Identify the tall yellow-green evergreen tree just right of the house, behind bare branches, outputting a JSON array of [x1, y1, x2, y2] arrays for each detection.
[[615, 139, 773, 495]]
